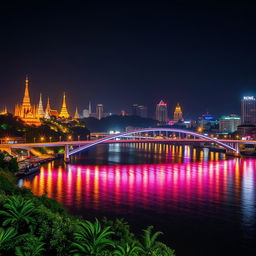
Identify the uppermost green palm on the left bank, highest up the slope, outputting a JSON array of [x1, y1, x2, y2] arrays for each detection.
[[0, 196, 35, 232]]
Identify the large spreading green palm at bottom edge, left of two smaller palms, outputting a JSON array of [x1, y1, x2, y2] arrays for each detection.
[[72, 219, 114, 256]]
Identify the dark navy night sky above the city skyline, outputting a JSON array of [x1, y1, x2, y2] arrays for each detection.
[[0, 1, 256, 117]]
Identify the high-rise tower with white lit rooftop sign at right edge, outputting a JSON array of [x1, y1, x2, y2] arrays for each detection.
[[241, 96, 256, 125]]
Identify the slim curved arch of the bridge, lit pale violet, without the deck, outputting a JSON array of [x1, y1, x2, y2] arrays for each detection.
[[67, 128, 238, 158]]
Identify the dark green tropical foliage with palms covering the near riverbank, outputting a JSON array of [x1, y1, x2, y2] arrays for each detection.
[[0, 153, 174, 256]]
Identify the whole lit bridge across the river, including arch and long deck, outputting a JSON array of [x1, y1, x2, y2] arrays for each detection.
[[0, 128, 251, 162]]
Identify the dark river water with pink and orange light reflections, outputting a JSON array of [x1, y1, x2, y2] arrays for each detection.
[[19, 144, 256, 256]]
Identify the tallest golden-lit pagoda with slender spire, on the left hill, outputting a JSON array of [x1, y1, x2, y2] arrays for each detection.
[[14, 76, 41, 126]]
